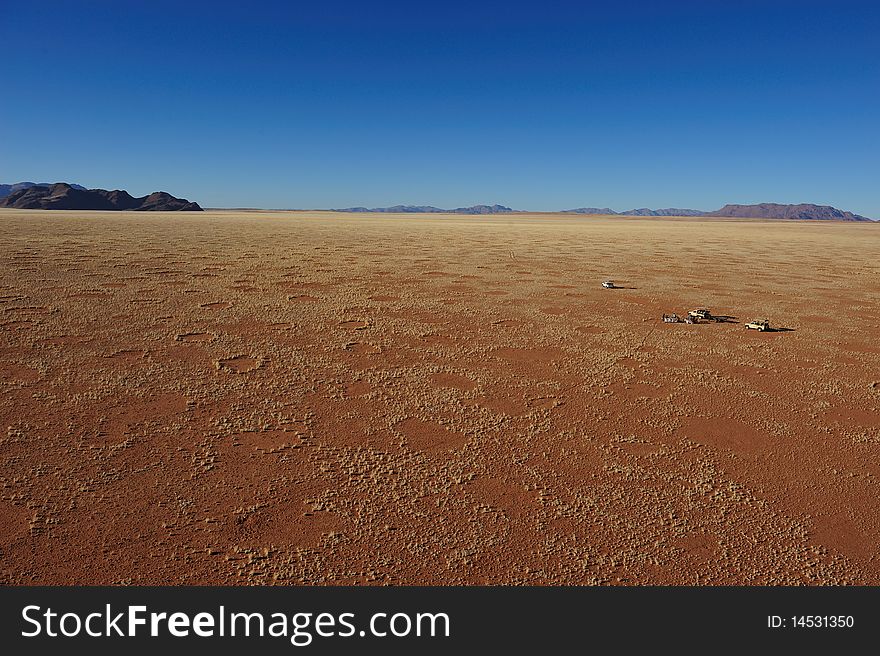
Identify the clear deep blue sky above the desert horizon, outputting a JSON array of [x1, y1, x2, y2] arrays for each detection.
[[0, 0, 880, 218]]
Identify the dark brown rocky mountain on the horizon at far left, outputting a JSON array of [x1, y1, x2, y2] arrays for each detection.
[[0, 182, 202, 212]]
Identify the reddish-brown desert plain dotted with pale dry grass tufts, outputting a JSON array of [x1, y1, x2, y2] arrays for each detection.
[[0, 210, 880, 585]]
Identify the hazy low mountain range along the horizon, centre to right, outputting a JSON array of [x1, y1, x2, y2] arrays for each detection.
[[333, 203, 871, 221]]
